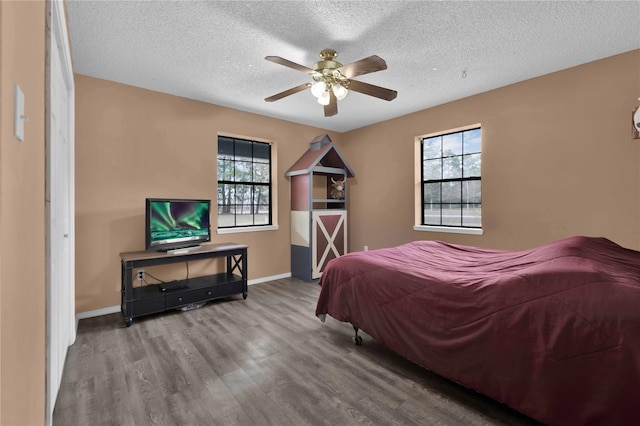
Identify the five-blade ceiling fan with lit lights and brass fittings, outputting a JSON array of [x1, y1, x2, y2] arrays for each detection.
[[265, 49, 398, 117]]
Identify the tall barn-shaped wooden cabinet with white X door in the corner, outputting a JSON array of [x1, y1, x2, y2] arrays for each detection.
[[286, 135, 355, 281]]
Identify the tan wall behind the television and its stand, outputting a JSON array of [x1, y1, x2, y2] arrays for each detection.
[[76, 75, 340, 312]]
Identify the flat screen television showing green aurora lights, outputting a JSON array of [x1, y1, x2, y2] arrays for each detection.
[[145, 198, 211, 251]]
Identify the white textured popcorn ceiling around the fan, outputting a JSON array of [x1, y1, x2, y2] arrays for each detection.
[[66, 0, 640, 132]]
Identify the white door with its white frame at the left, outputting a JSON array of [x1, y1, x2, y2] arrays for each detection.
[[45, 0, 76, 425]]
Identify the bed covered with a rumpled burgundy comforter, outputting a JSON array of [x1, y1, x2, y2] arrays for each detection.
[[316, 236, 640, 426]]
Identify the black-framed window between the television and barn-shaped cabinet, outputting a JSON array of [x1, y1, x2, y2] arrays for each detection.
[[218, 136, 272, 228]]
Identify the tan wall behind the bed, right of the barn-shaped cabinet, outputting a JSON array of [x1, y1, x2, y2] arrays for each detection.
[[341, 50, 640, 251]]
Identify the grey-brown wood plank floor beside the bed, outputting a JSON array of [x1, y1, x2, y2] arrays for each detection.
[[53, 278, 536, 426]]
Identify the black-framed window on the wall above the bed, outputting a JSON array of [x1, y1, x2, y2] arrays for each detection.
[[420, 127, 482, 228]]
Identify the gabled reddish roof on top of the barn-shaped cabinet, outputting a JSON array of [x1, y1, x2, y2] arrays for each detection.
[[285, 135, 355, 177]]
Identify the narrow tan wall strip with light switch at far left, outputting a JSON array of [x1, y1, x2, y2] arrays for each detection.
[[0, 1, 45, 425]]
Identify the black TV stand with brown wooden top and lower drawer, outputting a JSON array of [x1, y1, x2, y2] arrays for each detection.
[[120, 243, 248, 327]]
